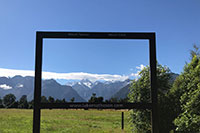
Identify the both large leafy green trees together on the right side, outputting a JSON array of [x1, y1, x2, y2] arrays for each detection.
[[128, 45, 200, 133]]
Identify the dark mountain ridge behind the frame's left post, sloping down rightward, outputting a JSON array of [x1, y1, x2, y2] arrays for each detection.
[[0, 76, 85, 102]]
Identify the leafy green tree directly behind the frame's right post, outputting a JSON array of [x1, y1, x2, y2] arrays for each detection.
[[128, 65, 172, 133]]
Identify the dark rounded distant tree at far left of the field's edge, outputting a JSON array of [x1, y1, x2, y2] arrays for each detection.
[[3, 94, 16, 108]]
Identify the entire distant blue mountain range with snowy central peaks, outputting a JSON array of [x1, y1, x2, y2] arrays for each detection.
[[0, 73, 178, 102]]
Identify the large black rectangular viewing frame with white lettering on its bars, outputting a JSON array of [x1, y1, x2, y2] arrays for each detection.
[[33, 31, 159, 133]]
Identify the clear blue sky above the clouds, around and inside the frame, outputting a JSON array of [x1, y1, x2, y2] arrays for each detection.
[[0, 0, 200, 82]]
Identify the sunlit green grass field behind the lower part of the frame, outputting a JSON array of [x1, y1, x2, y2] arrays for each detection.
[[0, 109, 131, 133]]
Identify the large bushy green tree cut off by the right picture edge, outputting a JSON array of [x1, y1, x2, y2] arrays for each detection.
[[170, 46, 200, 133]]
